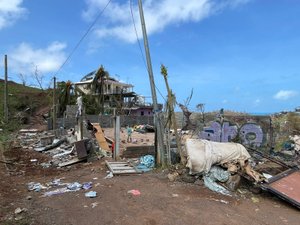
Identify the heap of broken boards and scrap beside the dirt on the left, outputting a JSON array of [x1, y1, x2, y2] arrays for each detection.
[[17, 129, 107, 168]]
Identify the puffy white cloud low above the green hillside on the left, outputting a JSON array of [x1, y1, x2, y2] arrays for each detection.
[[9, 42, 66, 74]]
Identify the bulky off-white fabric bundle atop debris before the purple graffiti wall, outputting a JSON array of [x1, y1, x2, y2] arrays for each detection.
[[185, 139, 251, 174]]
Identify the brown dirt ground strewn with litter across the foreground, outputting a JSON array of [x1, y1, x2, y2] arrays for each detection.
[[0, 142, 300, 225]]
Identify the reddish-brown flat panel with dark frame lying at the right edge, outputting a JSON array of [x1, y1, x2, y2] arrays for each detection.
[[262, 168, 300, 208]]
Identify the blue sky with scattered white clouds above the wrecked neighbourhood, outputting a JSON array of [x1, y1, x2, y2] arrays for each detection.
[[0, 0, 300, 113]]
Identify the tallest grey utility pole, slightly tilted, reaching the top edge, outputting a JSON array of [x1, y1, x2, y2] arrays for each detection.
[[138, 0, 165, 166]]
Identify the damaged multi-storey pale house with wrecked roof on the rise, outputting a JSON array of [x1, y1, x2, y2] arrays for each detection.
[[74, 66, 162, 116]]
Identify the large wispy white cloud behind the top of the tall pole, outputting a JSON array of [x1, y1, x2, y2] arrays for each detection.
[[82, 0, 249, 43]]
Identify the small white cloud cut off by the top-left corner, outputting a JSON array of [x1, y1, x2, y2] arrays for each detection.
[[0, 0, 27, 30]]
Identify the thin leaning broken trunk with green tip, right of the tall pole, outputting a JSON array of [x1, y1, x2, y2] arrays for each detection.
[[161, 65, 186, 165]]
